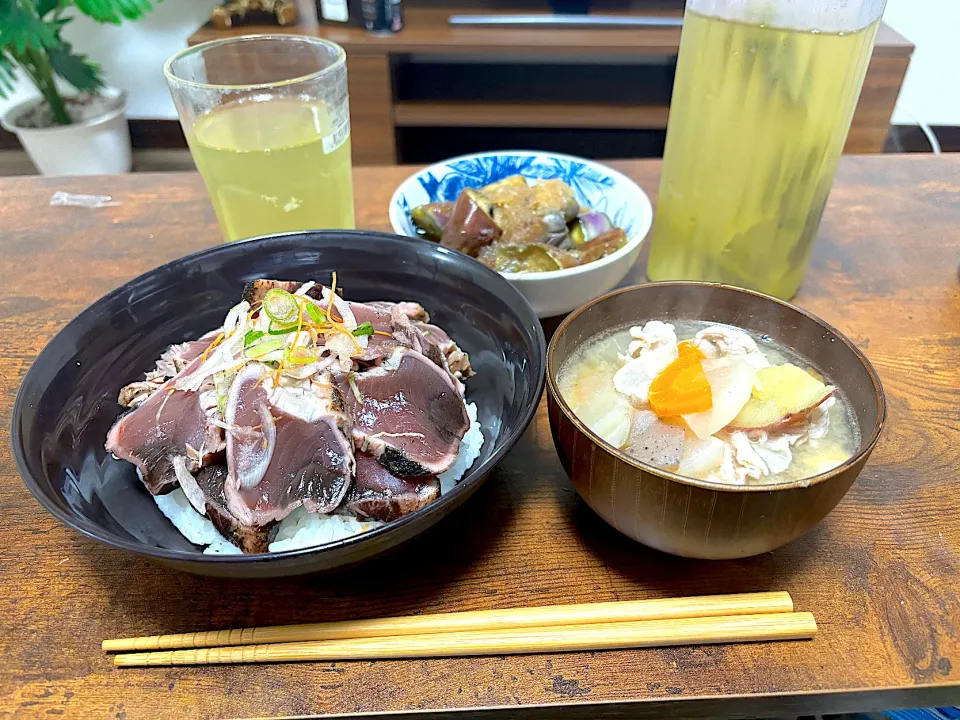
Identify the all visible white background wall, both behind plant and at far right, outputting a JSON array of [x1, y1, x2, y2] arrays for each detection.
[[0, 0, 960, 125]]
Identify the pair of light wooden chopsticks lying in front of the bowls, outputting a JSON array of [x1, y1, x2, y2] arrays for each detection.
[[103, 592, 817, 667]]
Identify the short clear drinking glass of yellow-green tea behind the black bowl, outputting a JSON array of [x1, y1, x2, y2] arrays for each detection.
[[164, 35, 354, 240]]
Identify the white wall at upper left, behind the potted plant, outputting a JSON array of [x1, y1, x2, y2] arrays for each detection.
[[0, 0, 219, 119]]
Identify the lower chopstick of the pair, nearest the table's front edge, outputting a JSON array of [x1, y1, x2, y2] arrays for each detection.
[[113, 612, 817, 667]]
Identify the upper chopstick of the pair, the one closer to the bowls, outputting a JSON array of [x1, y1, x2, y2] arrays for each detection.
[[102, 592, 793, 652]]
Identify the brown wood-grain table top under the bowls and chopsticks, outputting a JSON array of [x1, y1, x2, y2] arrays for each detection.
[[0, 157, 960, 719]]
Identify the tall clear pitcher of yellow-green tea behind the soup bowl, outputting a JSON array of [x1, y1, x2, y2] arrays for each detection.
[[647, 0, 885, 299]]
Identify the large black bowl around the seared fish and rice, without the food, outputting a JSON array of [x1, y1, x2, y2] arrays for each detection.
[[11, 231, 545, 578]]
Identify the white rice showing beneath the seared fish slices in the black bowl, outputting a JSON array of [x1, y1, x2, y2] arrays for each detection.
[[153, 403, 483, 555]]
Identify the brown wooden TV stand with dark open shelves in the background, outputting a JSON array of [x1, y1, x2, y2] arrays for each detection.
[[189, 2, 913, 165]]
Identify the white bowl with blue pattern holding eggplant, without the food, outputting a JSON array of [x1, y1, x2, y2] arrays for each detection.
[[389, 150, 653, 317]]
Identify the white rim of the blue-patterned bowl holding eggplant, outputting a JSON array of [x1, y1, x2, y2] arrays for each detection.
[[387, 150, 653, 282]]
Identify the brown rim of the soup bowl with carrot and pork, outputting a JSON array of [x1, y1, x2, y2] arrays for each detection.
[[546, 280, 887, 493]]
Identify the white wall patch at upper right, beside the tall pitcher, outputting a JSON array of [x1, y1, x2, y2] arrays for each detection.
[[883, 0, 960, 125]]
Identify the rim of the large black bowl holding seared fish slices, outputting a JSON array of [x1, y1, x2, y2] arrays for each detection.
[[10, 230, 547, 565]]
